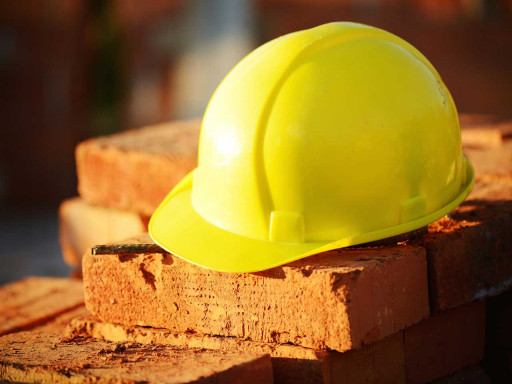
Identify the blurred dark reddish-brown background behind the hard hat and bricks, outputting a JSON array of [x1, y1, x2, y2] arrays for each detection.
[[0, 0, 512, 284]]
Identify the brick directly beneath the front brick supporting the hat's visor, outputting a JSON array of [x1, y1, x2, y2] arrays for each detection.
[[67, 316, 405, 384]]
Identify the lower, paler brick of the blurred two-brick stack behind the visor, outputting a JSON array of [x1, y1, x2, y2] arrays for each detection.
[[59, 197, 149, 266]]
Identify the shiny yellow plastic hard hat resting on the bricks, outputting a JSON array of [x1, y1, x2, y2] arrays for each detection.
[[149, 23, 474, 272]]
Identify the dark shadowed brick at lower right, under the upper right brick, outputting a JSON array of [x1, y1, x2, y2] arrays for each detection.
[[404, 302, 485, 383]]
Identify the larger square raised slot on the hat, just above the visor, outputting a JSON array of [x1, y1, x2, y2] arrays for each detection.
[[269, 211, 305, 243]]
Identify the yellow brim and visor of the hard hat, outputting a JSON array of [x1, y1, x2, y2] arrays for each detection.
[[149, 158, 475, 273]]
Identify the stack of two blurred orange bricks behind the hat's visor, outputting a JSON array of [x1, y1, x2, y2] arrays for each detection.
[[59, 120, 200, 266]]
